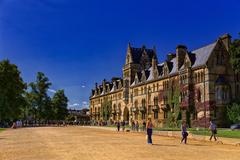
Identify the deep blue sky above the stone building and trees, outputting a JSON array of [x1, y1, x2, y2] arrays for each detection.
[[0, 0, 240, 108]]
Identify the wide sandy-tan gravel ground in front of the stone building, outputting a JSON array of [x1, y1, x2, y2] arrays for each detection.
[[0, 127, 240, 160]]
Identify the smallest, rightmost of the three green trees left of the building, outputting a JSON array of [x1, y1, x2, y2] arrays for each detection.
[[52, 90, 68, 120]]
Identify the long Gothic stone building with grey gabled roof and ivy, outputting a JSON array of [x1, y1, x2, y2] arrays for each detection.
[[90, 34, 240, 127]]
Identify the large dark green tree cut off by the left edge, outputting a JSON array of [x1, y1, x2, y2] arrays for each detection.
[[0, 60, 26, 121]]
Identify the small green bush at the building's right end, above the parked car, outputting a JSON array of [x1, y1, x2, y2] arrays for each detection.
[[227, 102, 240, 123]]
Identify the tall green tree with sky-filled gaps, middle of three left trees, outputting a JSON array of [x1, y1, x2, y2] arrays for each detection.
[[28, 72, 53, 120]]
